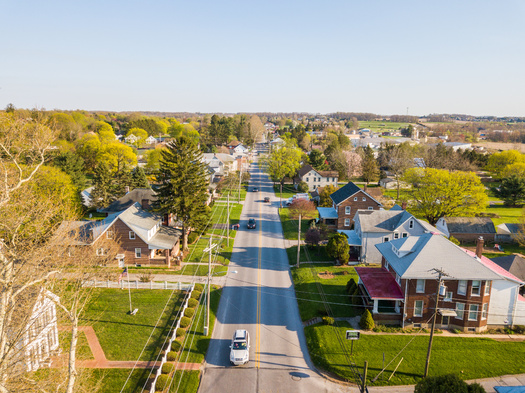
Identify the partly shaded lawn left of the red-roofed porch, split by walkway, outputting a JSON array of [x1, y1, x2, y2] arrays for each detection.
[[292, 264, 357, 321]]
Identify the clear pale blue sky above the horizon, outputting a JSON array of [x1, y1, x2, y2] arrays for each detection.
[[0, 0, 525, 116]]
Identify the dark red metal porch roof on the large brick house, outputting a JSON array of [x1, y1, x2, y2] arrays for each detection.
[[355, 267, 405, 300]]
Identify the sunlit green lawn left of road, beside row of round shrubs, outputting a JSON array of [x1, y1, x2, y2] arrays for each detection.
[[80, 289, 184, 360]]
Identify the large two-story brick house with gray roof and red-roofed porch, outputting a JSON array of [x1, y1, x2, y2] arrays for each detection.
[[355, 233, 525, 332]]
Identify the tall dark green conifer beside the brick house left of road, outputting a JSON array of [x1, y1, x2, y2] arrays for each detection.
[[155, 136, 210, 250]]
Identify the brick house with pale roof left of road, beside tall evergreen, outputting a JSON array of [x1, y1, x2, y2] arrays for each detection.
[[59, 203, 182, 267]]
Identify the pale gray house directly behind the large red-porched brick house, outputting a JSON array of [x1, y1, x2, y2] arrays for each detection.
[[338, 207, 443, 263]]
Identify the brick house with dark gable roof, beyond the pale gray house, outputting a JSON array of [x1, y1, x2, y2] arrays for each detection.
[[318, 182, 381, 229]]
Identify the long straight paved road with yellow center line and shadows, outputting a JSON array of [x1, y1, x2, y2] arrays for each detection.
[[199, 147, 357, 393]]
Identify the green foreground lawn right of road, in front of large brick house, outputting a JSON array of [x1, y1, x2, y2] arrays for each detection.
[[305, 325, 525, 386]]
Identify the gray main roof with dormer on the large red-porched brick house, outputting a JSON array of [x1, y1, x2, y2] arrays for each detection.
[[376, 233, 502, 280]]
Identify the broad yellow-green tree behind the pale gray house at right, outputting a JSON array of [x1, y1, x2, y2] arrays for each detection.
[[404, 168, 488, 225]]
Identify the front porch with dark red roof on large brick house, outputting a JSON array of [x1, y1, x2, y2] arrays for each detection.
[[355, 267, 404, 325]]
